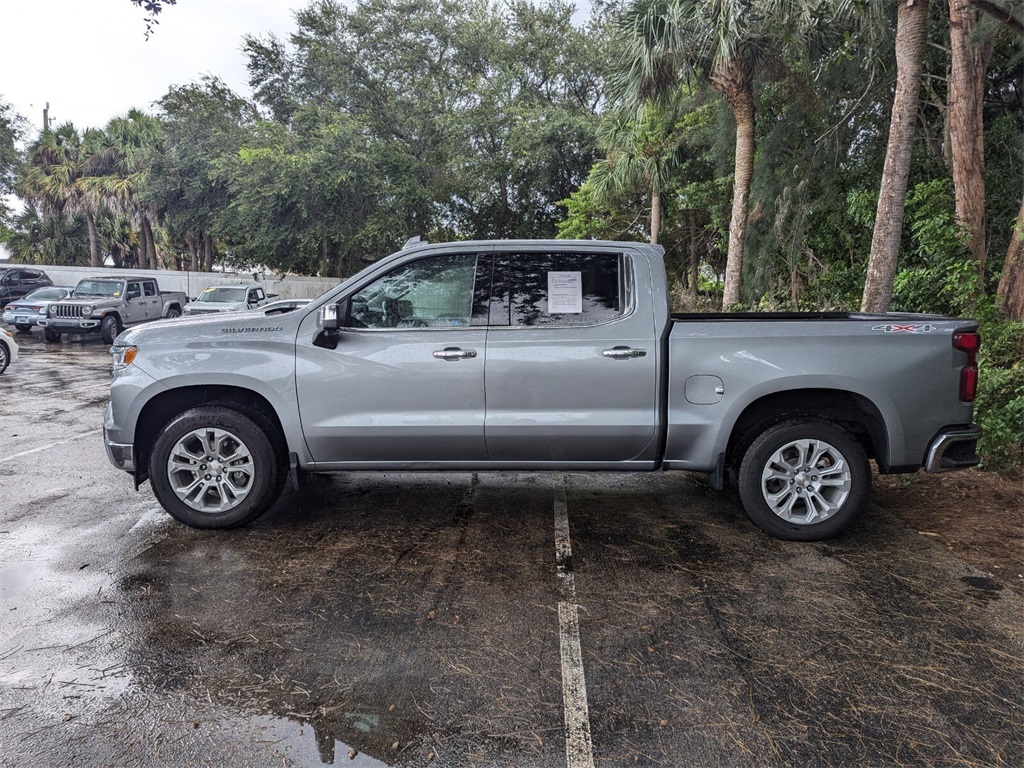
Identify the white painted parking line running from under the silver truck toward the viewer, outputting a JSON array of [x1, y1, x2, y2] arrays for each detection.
[[555, 485, 594, 768]]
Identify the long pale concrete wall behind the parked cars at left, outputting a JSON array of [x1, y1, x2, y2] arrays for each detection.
[[30, 264, 340, 299]]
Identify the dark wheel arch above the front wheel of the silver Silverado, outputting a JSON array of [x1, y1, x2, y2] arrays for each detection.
[[134, 385, 288, 481]]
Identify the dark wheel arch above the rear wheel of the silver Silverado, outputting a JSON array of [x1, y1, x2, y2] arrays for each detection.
[[726, 388, 889, 467]]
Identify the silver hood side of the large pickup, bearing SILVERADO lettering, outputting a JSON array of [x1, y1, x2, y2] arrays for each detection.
[[115, 309, 305, 346]]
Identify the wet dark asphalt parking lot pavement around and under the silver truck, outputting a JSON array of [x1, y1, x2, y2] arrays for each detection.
[[0, 331, 1024, 768]]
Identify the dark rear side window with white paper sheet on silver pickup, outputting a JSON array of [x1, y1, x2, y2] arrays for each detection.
[[492, 253, 626, 326]]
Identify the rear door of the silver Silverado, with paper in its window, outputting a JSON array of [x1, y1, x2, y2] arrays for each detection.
[[484, 248, 658, 464]]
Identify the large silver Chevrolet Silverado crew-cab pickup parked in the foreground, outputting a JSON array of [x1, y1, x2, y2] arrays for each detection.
[[104, 241, 980, 541]]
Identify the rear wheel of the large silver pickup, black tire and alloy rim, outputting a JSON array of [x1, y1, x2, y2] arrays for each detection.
[[738, 417, 871, 542]]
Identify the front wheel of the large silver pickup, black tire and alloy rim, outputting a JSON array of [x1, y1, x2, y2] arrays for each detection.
[[150, 404, 287, 528]]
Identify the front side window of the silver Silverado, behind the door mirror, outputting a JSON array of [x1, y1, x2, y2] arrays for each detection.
[[348, 254, 477, 328]]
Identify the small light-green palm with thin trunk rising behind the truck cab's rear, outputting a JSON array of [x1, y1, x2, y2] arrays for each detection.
[[591, 103, 683, 243]]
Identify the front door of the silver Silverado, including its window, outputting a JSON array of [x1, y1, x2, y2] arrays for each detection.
[[296, 253, 489, 462]]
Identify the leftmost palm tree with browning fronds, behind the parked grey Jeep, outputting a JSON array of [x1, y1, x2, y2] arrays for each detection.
[[20, 123, 104, 266]]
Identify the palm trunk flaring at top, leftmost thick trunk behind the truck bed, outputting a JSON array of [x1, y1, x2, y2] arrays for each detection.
[[712, 57, 755, 309]]
